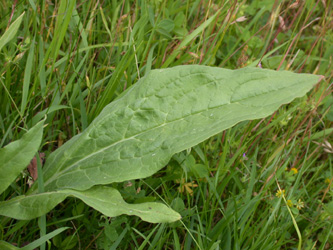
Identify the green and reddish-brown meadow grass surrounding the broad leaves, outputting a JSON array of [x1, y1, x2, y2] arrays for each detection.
[[0, 0, 333, 250]]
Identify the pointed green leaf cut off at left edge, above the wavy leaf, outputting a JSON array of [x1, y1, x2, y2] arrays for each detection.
[[0, 120, 44, 194]]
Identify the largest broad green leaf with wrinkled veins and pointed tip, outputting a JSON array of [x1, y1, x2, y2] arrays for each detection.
[[37, 65, 321, 191]]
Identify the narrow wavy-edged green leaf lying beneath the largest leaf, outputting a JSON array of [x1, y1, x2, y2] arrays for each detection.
[[0, 186, 180, 223]]
